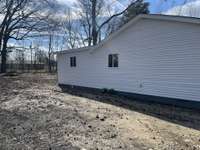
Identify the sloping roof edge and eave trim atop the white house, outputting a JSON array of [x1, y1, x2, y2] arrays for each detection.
[[56, 14, 200, 54]]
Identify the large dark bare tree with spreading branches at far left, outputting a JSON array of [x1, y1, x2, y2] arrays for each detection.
[[0, 0, 52, 73]]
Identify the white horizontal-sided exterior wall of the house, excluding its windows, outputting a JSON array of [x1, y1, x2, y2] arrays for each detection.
[[58, 19, 200, 101]]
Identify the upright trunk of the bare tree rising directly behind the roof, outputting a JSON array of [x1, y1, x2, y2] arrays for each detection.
[[92, 0, 98, 45]]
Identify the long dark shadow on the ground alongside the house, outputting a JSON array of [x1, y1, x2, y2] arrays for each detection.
[[61, 87, 200, 131]]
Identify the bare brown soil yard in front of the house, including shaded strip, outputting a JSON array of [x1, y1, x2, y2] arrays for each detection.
[[0, 74, 200, 150]]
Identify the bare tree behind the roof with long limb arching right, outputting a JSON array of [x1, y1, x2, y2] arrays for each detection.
[[75, 0, 148, 46]]
